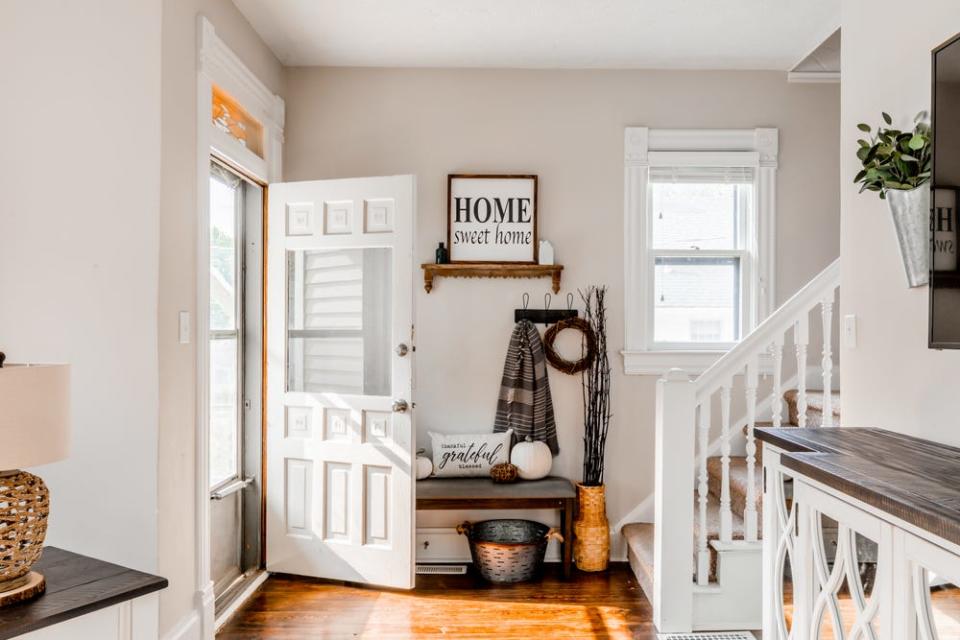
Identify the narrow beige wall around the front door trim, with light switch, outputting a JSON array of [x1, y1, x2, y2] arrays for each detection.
[[159, 0, 282, 634]]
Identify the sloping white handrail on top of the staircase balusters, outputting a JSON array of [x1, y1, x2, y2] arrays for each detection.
[[694, 258, 840, 403]]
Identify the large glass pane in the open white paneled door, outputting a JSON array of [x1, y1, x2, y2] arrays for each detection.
[[287, 247, 393, 396]]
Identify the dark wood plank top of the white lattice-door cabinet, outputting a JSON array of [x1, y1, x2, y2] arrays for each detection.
[[756, 427, 960, 544]]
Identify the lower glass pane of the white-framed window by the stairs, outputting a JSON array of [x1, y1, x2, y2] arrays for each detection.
[[653, 257, 740, 343]]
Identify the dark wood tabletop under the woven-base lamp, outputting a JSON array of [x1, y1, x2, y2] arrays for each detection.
[[0, 547, 167, 640]]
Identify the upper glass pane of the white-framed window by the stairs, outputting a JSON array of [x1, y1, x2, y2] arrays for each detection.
[[650, 182, 753, 249]]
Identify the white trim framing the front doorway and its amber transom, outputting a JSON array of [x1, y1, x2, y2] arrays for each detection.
[[193, 15, 285, 640]]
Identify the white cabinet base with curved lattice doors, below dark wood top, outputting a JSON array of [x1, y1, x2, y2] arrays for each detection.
[[763, 442, 960, 640]]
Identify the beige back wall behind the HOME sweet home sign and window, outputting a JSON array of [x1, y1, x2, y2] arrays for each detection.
[[284, 68, 840, 556]]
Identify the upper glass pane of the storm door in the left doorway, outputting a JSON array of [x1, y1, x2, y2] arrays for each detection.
[[210, 177, 239, 331]]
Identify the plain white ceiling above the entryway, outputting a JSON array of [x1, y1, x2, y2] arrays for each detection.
[[234, 0, 840, 71]]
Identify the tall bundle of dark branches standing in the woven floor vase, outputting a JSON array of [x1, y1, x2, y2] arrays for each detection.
[[579, 287, 610, 487]]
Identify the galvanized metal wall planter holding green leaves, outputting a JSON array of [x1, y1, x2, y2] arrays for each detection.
[[885, 186, 930, 287]]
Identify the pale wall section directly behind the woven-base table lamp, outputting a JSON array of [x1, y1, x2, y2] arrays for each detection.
[[0, 0, 160, 571]]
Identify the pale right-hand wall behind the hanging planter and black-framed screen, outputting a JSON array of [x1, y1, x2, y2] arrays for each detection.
[[841, 5, 960, 445]]
